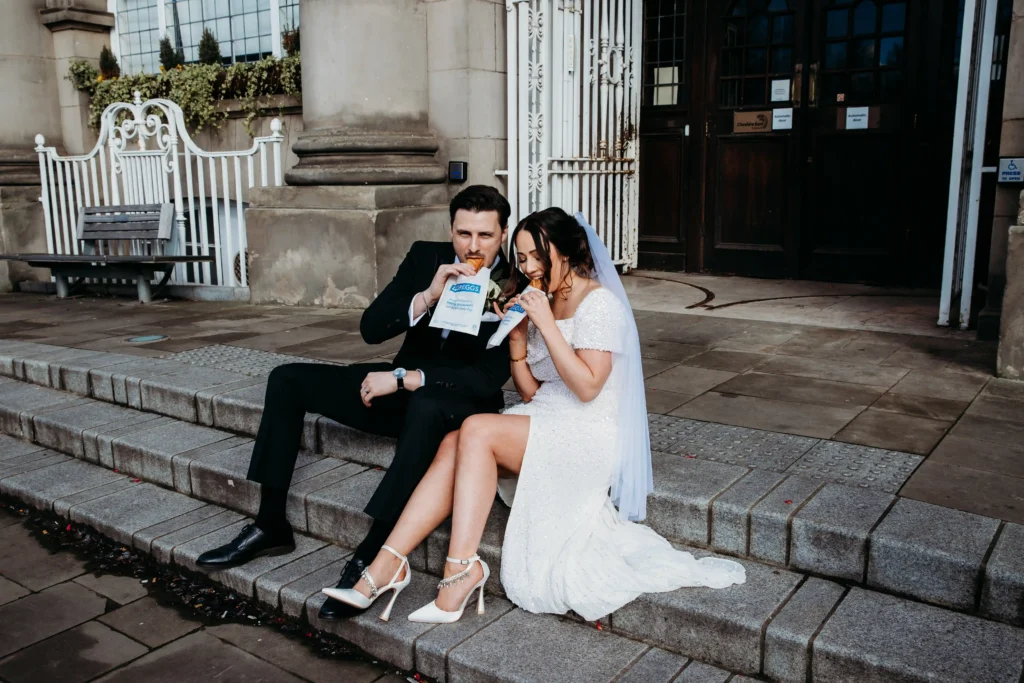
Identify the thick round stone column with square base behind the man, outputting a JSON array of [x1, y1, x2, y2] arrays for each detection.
[[246, 0, 449, 308]]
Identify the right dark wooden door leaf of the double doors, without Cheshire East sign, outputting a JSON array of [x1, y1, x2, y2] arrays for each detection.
[[801, 0, 929, 284]]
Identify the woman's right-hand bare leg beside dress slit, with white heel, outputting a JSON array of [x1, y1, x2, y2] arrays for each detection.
[[437, 415, 529, 611]]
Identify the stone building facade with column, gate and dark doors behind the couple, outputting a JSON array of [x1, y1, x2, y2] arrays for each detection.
[[0, 0, 1024, 374]]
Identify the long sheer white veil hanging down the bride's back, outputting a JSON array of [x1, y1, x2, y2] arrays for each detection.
[[575, 213, 654, 521]]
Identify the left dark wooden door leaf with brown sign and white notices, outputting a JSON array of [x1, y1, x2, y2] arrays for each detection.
[[705, 0, 809, 278]]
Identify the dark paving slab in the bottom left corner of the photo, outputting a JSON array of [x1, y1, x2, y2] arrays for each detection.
[[0, 622, 150, 683]]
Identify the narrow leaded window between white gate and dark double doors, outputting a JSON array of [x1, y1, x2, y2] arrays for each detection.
[[643, 0, 689, 106]]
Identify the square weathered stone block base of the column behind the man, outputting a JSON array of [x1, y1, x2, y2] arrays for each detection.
[[246, 184, 451, 308]]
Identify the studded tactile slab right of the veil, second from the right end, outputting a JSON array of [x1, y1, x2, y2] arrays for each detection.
[[680, 424, 818, 472]]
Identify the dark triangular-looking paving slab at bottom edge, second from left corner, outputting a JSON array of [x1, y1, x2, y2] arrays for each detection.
[[90, 633, 301, 683]]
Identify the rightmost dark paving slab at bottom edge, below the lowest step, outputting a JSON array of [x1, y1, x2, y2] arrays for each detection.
[[206, 624, 384, 683]]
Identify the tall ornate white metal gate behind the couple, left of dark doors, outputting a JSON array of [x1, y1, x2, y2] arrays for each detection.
[[506, 0, 643, 268]]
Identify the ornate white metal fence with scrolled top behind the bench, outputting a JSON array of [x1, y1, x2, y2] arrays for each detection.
[[36, 91, 285, 287]]
